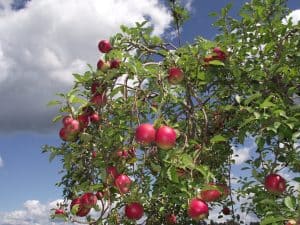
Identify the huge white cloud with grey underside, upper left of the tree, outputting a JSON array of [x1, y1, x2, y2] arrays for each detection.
[[0, 0, 171, 132]]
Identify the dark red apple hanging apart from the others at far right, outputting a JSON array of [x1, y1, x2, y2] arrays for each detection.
[[265, 173, 286, 194]]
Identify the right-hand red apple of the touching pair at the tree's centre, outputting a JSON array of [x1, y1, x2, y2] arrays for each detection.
[[155, 126, 176, 150]]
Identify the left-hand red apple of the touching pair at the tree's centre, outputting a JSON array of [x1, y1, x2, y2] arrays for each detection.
[[135, 123, 155, 145]]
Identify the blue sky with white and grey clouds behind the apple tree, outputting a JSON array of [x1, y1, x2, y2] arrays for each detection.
[[0, 0, 300, 225]]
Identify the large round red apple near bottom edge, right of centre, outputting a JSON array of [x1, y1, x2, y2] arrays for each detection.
[[188, 198, 208, 220]]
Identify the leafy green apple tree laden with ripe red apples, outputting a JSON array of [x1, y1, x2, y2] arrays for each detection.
[[44, 0, 300, 225]]
